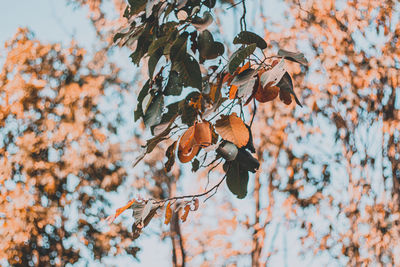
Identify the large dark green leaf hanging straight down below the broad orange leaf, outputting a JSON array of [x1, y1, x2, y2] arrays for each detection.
[[223, 160, 249, 199]]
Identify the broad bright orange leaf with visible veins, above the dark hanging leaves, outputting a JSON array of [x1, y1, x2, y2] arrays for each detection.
[[215, 113, 249, 148]]
